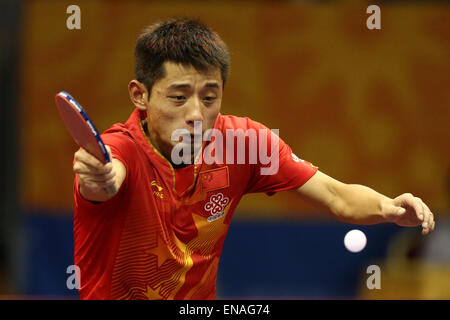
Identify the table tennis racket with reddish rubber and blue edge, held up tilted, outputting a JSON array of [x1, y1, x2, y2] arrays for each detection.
[[55, 91, 116, 194]]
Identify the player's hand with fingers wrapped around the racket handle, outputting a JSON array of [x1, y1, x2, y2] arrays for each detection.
[[73, 146, 116, 196]]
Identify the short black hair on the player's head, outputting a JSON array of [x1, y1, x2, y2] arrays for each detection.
[[135, 18, 230, 98]]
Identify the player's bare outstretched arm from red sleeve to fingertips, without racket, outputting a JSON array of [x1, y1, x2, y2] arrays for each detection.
[[297, 171, 435, 234]]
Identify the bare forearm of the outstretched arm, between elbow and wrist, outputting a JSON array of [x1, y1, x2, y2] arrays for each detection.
[[335, 184, 392, 225]]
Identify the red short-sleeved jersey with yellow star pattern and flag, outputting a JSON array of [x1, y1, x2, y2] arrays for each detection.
[[74, 109, 317, 299]]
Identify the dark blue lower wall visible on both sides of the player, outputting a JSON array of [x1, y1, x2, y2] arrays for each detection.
[[24, 213, 401, 299]]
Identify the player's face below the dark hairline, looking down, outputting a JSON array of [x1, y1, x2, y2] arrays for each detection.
[[147, 62, 222, 164]]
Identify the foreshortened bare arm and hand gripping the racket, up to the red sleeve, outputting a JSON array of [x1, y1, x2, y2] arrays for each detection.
[[73, 146, 126, 202]]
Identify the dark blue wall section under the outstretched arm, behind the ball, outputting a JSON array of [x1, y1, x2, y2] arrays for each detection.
[[218, 221, 401, 298]]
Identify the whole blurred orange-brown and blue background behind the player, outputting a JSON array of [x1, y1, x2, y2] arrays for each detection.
[[0, 0, 450, 299]]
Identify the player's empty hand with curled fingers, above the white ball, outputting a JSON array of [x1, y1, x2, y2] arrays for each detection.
[[384, 193, 435, 235]]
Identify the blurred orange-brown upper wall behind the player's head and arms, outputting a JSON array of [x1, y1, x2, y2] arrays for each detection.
[[21, 1, 450, 217]]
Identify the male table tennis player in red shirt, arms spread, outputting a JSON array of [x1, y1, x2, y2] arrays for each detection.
[[73, 19, 435, 299]]
